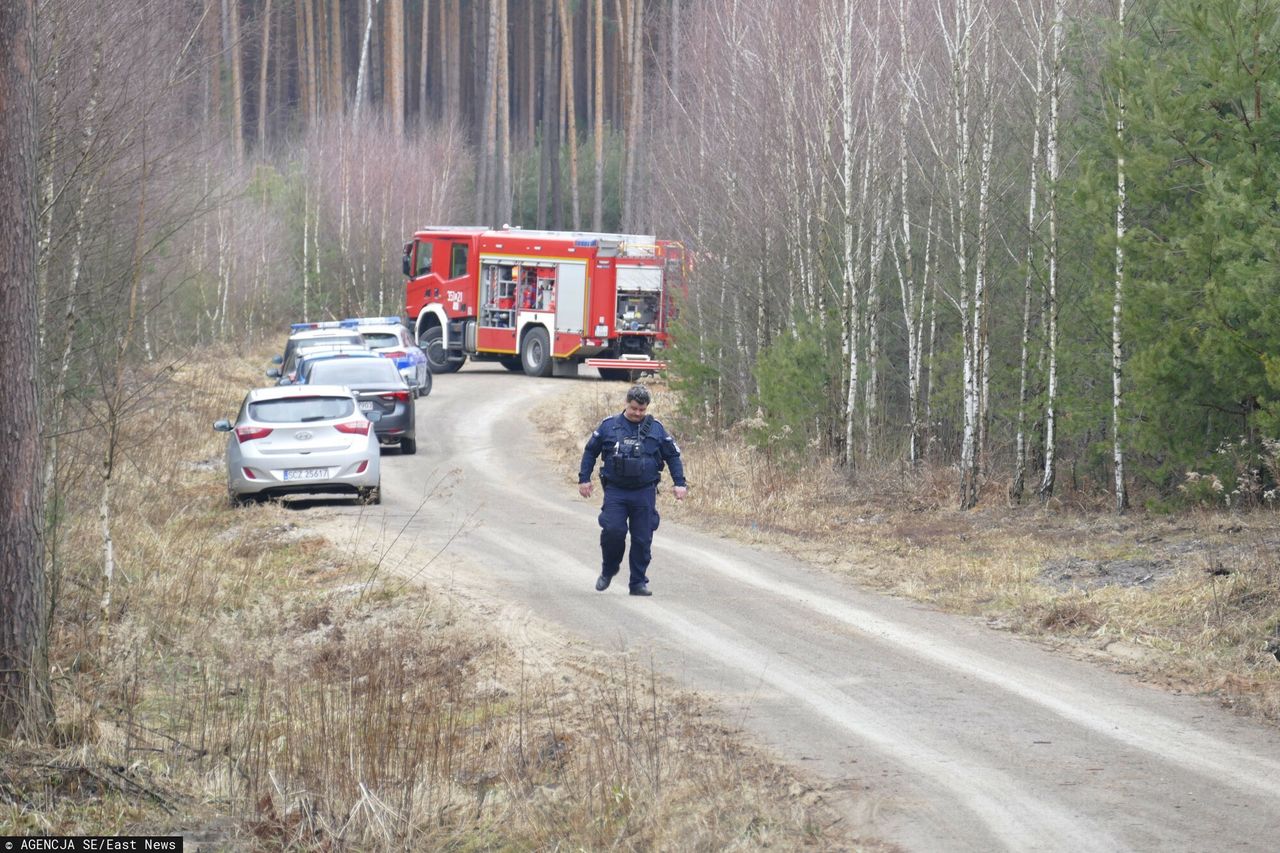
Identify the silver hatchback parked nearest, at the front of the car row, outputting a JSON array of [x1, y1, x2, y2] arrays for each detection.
[[214, 386, 381, 503]]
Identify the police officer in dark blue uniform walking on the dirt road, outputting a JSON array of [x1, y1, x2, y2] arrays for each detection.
[[577, 386, 689, 596]]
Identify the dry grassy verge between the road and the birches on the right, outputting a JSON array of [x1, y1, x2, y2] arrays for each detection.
[[535, 383, 1280, 721]]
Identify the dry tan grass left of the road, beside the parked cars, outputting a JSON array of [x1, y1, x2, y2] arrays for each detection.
[[0, 352, 850, 850]]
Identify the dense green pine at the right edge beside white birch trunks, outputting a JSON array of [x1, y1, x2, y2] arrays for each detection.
[[1124, 0, 1280, 476]]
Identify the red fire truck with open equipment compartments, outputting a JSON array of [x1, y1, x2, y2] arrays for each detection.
[[404, 227, 685, 379]]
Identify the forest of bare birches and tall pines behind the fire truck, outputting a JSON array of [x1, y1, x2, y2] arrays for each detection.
[[27, 0, 1280, 506]]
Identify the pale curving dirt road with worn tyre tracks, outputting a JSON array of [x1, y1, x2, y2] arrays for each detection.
[[306, 365, 1280, 852]]
